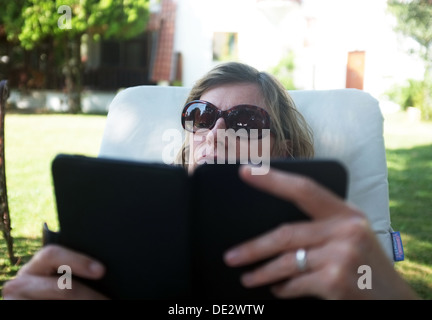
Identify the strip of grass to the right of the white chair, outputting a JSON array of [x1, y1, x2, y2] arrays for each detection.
[[385, 113, 432, 300]]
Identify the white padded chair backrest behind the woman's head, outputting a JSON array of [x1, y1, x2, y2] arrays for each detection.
[[99, 86, 393, 259]]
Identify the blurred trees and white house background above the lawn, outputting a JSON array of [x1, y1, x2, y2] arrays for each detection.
[[0, 0, 432, 119]]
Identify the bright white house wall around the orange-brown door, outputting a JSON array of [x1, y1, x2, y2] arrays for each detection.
[[303, 0, 423, 98]]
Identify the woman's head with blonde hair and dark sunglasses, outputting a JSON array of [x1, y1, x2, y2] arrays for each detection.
[[177, 63, 314, 171]]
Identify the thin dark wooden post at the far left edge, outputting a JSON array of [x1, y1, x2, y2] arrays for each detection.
[[0, 80, 18, 265]]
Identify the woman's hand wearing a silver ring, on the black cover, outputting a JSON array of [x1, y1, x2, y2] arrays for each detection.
[[225, 166, 418, 299]]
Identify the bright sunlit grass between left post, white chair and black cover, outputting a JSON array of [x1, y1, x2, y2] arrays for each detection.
[[5, 114, 106, 237]]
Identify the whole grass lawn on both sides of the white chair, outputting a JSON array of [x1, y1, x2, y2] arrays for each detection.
[[0, 113, 432, 299]]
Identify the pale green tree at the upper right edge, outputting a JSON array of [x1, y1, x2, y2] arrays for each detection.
[[387, 0, 432, 119]]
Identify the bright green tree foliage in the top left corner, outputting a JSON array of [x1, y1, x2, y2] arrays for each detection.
[[0, 0, 149, 49]]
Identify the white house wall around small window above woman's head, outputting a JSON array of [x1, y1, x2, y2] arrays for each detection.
[[174, 0, 303, 86]]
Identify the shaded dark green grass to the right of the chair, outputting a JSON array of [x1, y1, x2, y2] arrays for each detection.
[[387, 145, 432, 299]]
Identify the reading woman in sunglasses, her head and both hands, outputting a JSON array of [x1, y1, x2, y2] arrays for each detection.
[[3, 63, 418, 299]]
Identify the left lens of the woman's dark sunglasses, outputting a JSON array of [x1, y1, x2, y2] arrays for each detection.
[[183, 102, 217, 132]]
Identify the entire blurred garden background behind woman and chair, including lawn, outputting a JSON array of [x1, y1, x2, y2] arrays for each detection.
[[0, 0, 432, 299]]
